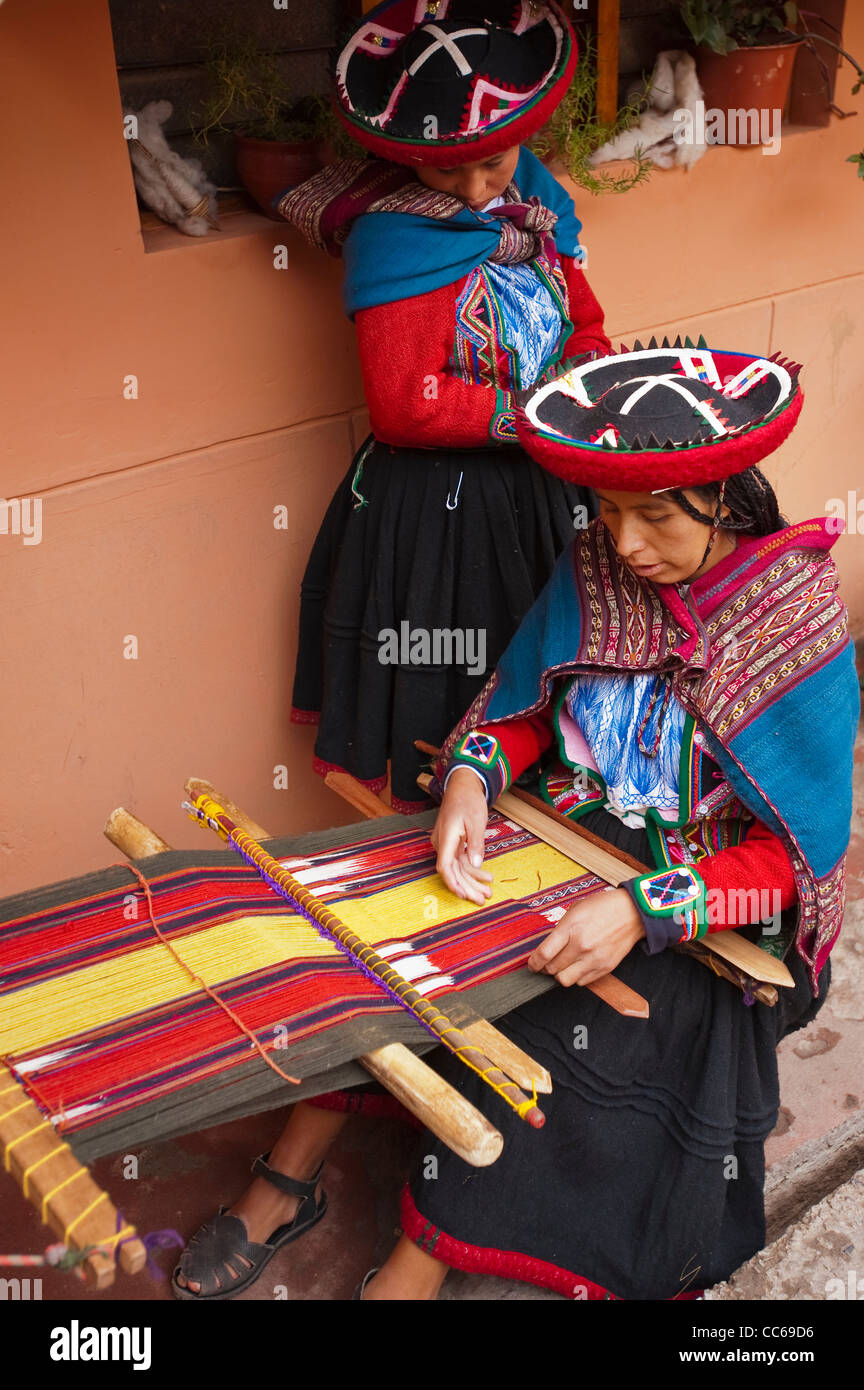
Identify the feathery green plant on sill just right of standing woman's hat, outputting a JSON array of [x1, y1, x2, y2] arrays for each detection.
[[531, 33, 654, 193]]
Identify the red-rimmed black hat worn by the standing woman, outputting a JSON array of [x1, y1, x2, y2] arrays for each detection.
[[335, 0, 576, 168]]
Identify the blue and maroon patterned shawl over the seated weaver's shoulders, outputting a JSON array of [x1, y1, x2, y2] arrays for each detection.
[[442, 518, 860, 987]]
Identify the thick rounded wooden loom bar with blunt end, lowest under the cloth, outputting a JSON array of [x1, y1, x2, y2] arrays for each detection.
[[114, 783, 511, 1168]]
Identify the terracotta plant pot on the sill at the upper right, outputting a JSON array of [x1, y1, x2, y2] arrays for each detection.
[[681, 0, 801, 125]]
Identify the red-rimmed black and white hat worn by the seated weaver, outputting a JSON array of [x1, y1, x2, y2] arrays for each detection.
[[517, 338, 803, 492]]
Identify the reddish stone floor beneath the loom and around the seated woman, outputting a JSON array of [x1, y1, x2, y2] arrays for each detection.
[[6, 722, 864, 1300]]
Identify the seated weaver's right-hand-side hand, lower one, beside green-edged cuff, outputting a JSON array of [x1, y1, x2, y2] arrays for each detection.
[[528, 888, 645, 984]]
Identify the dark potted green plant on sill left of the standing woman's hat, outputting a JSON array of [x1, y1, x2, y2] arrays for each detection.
[[196, 28, 338, 221]]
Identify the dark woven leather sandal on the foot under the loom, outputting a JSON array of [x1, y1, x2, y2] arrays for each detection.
[[171, 1154, 326, 1302]]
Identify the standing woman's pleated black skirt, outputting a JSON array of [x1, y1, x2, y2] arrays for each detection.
[[292, 439, 595, 812]]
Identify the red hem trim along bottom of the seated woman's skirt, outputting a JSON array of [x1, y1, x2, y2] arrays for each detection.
[[401, 1184, 701, 1302]]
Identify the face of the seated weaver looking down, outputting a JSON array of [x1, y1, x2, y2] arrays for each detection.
[[595, 488, 735, 584]]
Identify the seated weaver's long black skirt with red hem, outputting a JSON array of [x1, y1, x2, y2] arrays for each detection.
[[403, 812, 829, 1300]]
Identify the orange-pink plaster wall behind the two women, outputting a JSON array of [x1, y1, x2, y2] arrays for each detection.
[[0, 0, 864, 892]]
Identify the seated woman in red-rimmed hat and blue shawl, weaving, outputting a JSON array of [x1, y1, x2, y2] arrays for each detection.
[[181, 348, 858, 1300]]
